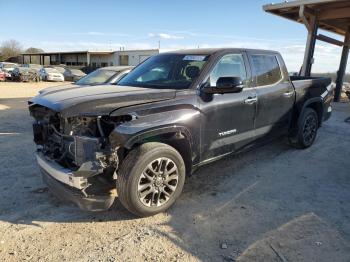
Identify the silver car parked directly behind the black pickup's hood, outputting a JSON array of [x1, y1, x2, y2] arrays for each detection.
[[39, 66, 134, 94]]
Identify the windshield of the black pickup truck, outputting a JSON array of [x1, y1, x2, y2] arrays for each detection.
[[117, 54, 208, 89]]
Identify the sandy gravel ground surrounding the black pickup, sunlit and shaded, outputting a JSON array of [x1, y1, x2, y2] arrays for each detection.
[[0, 84, 350, 262]]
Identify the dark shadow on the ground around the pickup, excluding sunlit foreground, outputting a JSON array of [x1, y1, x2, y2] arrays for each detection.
[[0, 99, 350, 261]]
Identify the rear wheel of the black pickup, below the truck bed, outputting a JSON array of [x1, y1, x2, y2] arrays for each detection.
[[289, 108, 319, 149]]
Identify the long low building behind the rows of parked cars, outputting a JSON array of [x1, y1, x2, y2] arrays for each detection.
[[21, 49, 159, 68]]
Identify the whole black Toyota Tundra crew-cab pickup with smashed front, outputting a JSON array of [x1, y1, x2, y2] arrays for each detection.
[[29, 49, 332, 217]]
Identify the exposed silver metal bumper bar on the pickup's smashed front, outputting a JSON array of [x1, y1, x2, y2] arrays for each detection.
[[35, 153, 88, 190]]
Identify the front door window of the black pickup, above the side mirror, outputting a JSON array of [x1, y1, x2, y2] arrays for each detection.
[[209, 54, 247, 86]]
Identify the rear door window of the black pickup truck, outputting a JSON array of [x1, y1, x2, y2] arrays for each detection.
[[251, 55, 282, 86]]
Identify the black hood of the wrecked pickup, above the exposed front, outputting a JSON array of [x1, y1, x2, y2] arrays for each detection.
[[29, 85, 176, 117]]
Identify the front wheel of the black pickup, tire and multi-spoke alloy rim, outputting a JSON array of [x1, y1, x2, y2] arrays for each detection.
[[117, 142, 186, 217]]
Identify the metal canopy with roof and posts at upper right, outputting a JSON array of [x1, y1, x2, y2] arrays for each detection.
[[263, 0, 350, 102]]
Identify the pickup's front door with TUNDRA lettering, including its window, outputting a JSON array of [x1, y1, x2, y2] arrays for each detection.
[[200, 52, 257, 161]]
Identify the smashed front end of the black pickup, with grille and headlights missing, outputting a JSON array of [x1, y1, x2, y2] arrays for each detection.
[[29, 104, 126, 211]]
